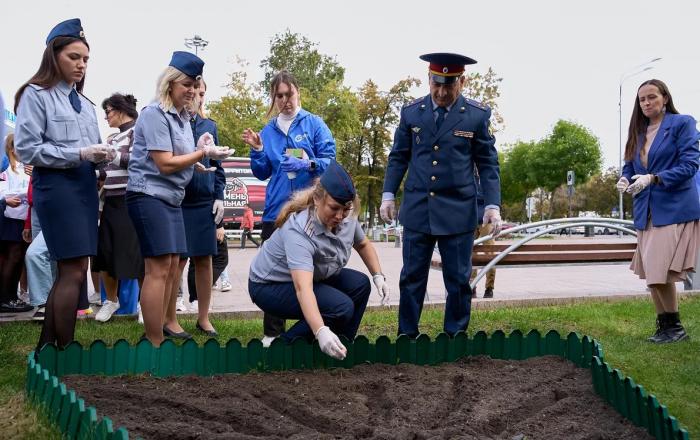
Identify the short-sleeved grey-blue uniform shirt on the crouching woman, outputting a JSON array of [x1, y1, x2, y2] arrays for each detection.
[[248, 208, 365, 283]]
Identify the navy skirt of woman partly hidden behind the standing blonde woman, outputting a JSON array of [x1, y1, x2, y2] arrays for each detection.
[[181, 201, 217, 258]]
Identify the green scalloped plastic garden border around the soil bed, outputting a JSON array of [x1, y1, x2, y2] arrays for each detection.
[[26, 330, 690, 440]]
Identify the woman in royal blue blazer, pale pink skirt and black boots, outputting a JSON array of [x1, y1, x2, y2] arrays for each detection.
[[617, 79, 700, 343]]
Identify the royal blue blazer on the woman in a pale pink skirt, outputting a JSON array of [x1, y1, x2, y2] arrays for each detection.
[[622, 113, 700, 230]]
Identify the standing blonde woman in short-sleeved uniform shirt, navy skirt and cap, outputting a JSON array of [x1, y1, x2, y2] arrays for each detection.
[[126, 52, 229, 347]]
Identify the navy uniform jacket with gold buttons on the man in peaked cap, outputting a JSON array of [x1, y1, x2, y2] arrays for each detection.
[[383, 95, 501, 235]]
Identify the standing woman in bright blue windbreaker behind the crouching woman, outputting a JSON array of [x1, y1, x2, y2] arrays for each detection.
[[242, 70, 335, 346]]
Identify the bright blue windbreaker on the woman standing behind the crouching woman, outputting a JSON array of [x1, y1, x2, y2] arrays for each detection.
[[250, 109, 335, 222]]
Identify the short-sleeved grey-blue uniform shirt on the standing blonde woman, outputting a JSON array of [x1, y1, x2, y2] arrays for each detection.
[[126, 102, 195, 206]]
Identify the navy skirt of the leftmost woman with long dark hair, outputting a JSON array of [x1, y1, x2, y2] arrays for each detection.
[[32, 162, 99, 260]]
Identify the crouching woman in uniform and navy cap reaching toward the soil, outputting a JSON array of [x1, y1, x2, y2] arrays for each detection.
[[248, 161, 389, 359]]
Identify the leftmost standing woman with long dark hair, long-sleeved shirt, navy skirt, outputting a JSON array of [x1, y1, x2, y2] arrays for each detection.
[[15, 18, 116, 348]]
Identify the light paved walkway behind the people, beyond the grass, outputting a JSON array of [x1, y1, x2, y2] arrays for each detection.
[[0, 237, 683, 321]]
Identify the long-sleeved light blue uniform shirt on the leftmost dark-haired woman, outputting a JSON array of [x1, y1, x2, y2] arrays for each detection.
[[15, 81, 101, 168]]
